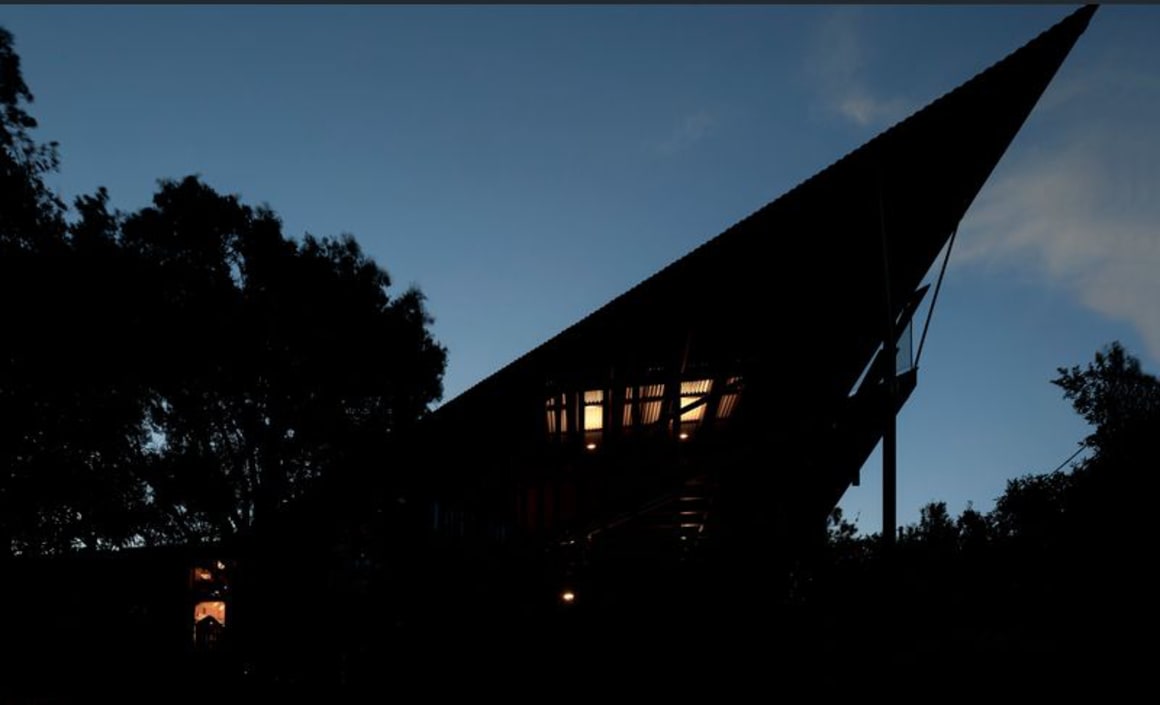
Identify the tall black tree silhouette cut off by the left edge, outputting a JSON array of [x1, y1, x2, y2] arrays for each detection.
[[0, 28, 140, 555]]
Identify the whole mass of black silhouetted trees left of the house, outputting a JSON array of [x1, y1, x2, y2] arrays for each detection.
[[0, 28, 445, 558]]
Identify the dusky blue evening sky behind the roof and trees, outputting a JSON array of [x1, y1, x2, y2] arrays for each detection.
[[0, 6, 1160, 531]]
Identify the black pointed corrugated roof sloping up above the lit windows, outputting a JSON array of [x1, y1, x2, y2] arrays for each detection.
[[435, 6, 1095, 435]]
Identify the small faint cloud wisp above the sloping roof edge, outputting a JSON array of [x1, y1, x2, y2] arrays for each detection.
[[807, 7, 913, 126]]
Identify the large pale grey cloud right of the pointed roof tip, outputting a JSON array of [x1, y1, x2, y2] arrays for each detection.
[[956, 72, 1160, 359]]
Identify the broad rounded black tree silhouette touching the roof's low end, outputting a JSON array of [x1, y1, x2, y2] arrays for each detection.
[[122, 177, 445, 544]]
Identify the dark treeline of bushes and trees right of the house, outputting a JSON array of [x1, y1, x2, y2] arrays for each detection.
[[796, 343, 1160, 679]]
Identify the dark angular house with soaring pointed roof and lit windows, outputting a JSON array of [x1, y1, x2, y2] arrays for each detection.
[[408, 7, 1095, 607]]
